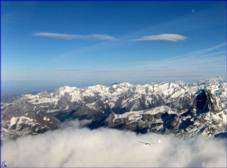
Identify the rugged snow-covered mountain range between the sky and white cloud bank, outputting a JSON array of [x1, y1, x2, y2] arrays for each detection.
[[1, 80, 227, 138]]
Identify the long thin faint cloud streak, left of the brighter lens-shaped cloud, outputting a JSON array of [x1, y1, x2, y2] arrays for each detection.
[[32, 32, 116, 41]]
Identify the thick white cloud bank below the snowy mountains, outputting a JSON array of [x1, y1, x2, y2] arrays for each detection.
[[2, 121, 226, 167]]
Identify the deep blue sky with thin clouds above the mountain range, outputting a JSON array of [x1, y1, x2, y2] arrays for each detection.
[[1, 2, 227, 87]]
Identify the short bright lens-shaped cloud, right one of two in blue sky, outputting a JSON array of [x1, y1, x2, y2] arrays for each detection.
[[135, 33, 186, 42]]
